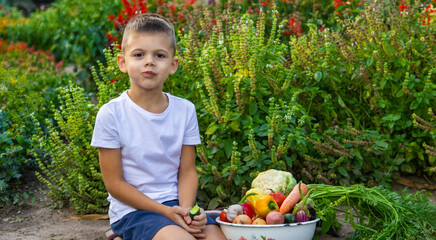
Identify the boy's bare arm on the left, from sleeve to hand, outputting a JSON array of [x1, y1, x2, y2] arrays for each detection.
[[99, 148, 201, 234]]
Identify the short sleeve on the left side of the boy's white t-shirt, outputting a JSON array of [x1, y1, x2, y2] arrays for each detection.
[[91, 105, 121, 148]]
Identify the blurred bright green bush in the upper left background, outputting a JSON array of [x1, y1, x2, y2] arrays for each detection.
[[3, 0, 121, 69]]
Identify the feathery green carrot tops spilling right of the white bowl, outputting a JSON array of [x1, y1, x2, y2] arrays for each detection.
[[308, 184, 436, 239]]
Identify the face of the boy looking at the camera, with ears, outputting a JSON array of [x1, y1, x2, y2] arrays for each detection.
[[117, 32, 178, 94]]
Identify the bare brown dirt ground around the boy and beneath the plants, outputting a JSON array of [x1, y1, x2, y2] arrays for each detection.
[[0, 174, 436, 240]]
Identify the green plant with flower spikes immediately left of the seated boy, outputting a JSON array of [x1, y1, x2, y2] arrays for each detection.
[[35, 83, 108, 214]]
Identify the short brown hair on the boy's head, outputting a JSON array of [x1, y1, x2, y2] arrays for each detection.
[[121, 13, 176, 55]]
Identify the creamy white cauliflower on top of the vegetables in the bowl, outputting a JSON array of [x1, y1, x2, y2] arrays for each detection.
[[251, 169, 297, 194]]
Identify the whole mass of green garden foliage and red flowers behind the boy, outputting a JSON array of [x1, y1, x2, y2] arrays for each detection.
[[0, 0, 436, 213]]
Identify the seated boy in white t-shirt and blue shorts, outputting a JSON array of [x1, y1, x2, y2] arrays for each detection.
[[91, 13, 226, 240]]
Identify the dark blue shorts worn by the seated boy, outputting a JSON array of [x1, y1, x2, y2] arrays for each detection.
[[111, 200, 218, 240]]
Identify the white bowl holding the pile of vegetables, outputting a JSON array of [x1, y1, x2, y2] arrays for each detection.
[[216, 217, 319, 240]]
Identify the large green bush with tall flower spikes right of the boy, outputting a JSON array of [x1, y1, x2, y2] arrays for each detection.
[[172, 2, 436, 205]]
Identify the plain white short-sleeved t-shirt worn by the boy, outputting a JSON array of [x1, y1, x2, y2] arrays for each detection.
[[91, 91, 201, 224]]
